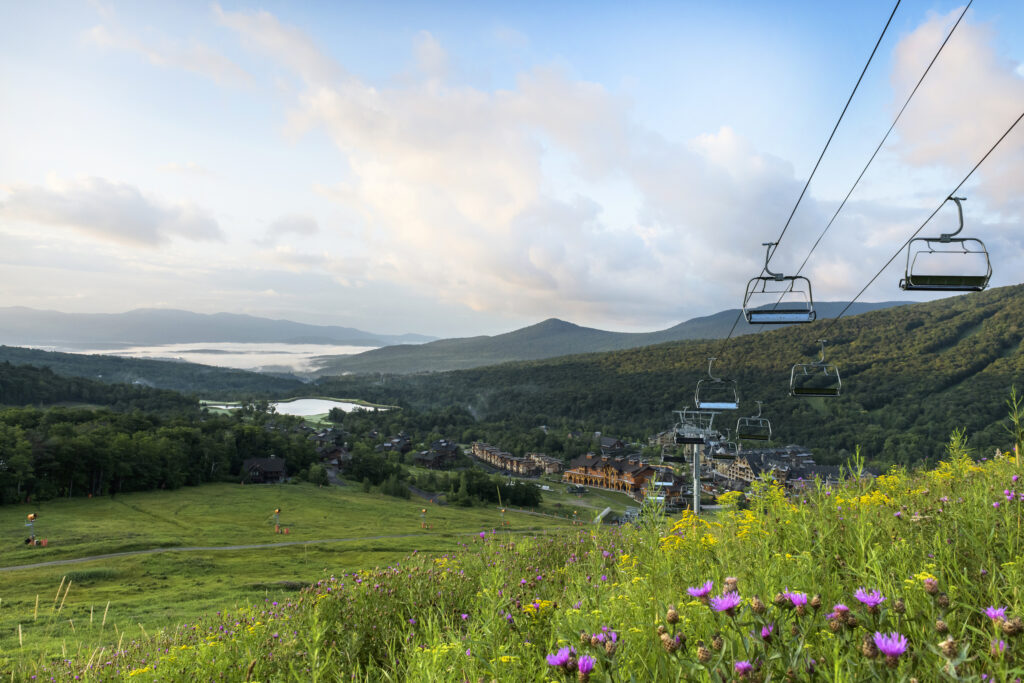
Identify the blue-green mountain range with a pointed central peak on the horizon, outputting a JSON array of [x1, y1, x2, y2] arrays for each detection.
[[317, 301, 912, 376]]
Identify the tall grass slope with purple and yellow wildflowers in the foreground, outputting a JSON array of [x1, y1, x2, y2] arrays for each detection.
[[0, 433, 1024, 681]]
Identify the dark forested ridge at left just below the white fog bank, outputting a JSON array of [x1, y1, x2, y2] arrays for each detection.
[[0, 346, 305, 395]]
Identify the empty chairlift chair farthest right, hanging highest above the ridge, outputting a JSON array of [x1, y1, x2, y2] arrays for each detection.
[[899, 197, 992, 292]]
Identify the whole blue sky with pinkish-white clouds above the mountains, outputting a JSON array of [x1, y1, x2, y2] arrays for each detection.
[[0, 0, 1024, 337]]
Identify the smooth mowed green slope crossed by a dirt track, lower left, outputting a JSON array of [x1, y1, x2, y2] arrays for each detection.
[[0, 483, 568, 656]]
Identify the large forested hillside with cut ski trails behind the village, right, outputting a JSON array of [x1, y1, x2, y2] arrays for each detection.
[[319, 286, 1024, 471]]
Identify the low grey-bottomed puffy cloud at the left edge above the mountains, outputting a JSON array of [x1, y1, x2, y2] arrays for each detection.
[[0, 177, 222, 247]]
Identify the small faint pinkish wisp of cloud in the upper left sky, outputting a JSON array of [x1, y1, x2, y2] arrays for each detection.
[[85, 26, 252, 85]]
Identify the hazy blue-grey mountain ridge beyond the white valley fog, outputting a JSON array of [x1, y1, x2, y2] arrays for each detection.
[[0, 306, 435, 349]]
